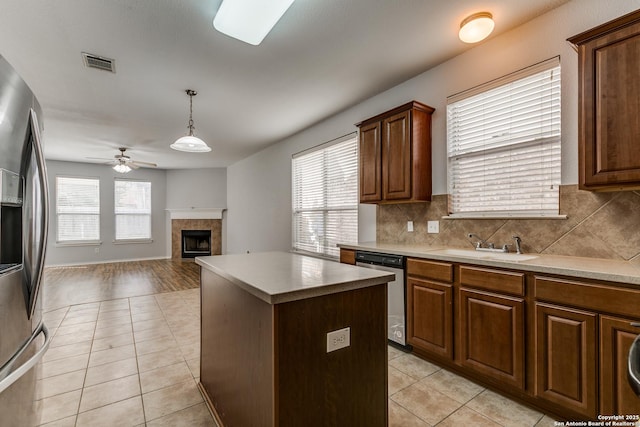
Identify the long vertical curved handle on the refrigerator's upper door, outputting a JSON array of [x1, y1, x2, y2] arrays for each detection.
[[27, 108, 49, 318]]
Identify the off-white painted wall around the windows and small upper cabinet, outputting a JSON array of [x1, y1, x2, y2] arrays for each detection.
[[227, 0, 640, 253]]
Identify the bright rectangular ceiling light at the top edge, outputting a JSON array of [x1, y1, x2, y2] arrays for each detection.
[[213, 0, 294, 46]]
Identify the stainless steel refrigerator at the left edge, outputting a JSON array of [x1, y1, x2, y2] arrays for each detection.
[[0, 56, 50, 427]]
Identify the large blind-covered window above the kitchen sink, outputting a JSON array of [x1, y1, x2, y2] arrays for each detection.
[[447, 58, 560, 217]]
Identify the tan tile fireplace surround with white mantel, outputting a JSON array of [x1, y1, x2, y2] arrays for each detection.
[[169, 209, 223, 259]]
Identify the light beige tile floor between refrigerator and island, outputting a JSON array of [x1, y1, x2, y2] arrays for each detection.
[[36, 289, 216, 427]]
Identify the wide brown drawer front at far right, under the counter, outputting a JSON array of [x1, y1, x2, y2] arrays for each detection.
[[534, 276, 640, 318]]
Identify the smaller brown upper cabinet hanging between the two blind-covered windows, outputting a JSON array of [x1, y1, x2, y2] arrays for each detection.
[[356, 101, 435, 203]]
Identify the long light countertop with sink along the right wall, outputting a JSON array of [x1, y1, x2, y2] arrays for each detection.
[[338, 242, 640, 285]]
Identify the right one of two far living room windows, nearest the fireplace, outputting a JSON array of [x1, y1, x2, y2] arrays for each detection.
[[114, 179, 151, 240]]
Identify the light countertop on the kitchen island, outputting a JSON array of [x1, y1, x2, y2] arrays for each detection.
[[196, 252, 395, 304]]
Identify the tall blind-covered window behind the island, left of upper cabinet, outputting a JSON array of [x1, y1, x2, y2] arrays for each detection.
[[292, 135, 358, 258]]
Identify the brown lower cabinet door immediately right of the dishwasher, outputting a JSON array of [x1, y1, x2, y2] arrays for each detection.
[[407, 276, 453, 359]]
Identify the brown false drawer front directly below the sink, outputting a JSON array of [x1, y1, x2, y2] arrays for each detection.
[[460, 265, 524, 296]]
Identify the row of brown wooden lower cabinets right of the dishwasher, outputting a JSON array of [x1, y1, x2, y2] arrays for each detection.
[[341, 251, 640, 420]]
